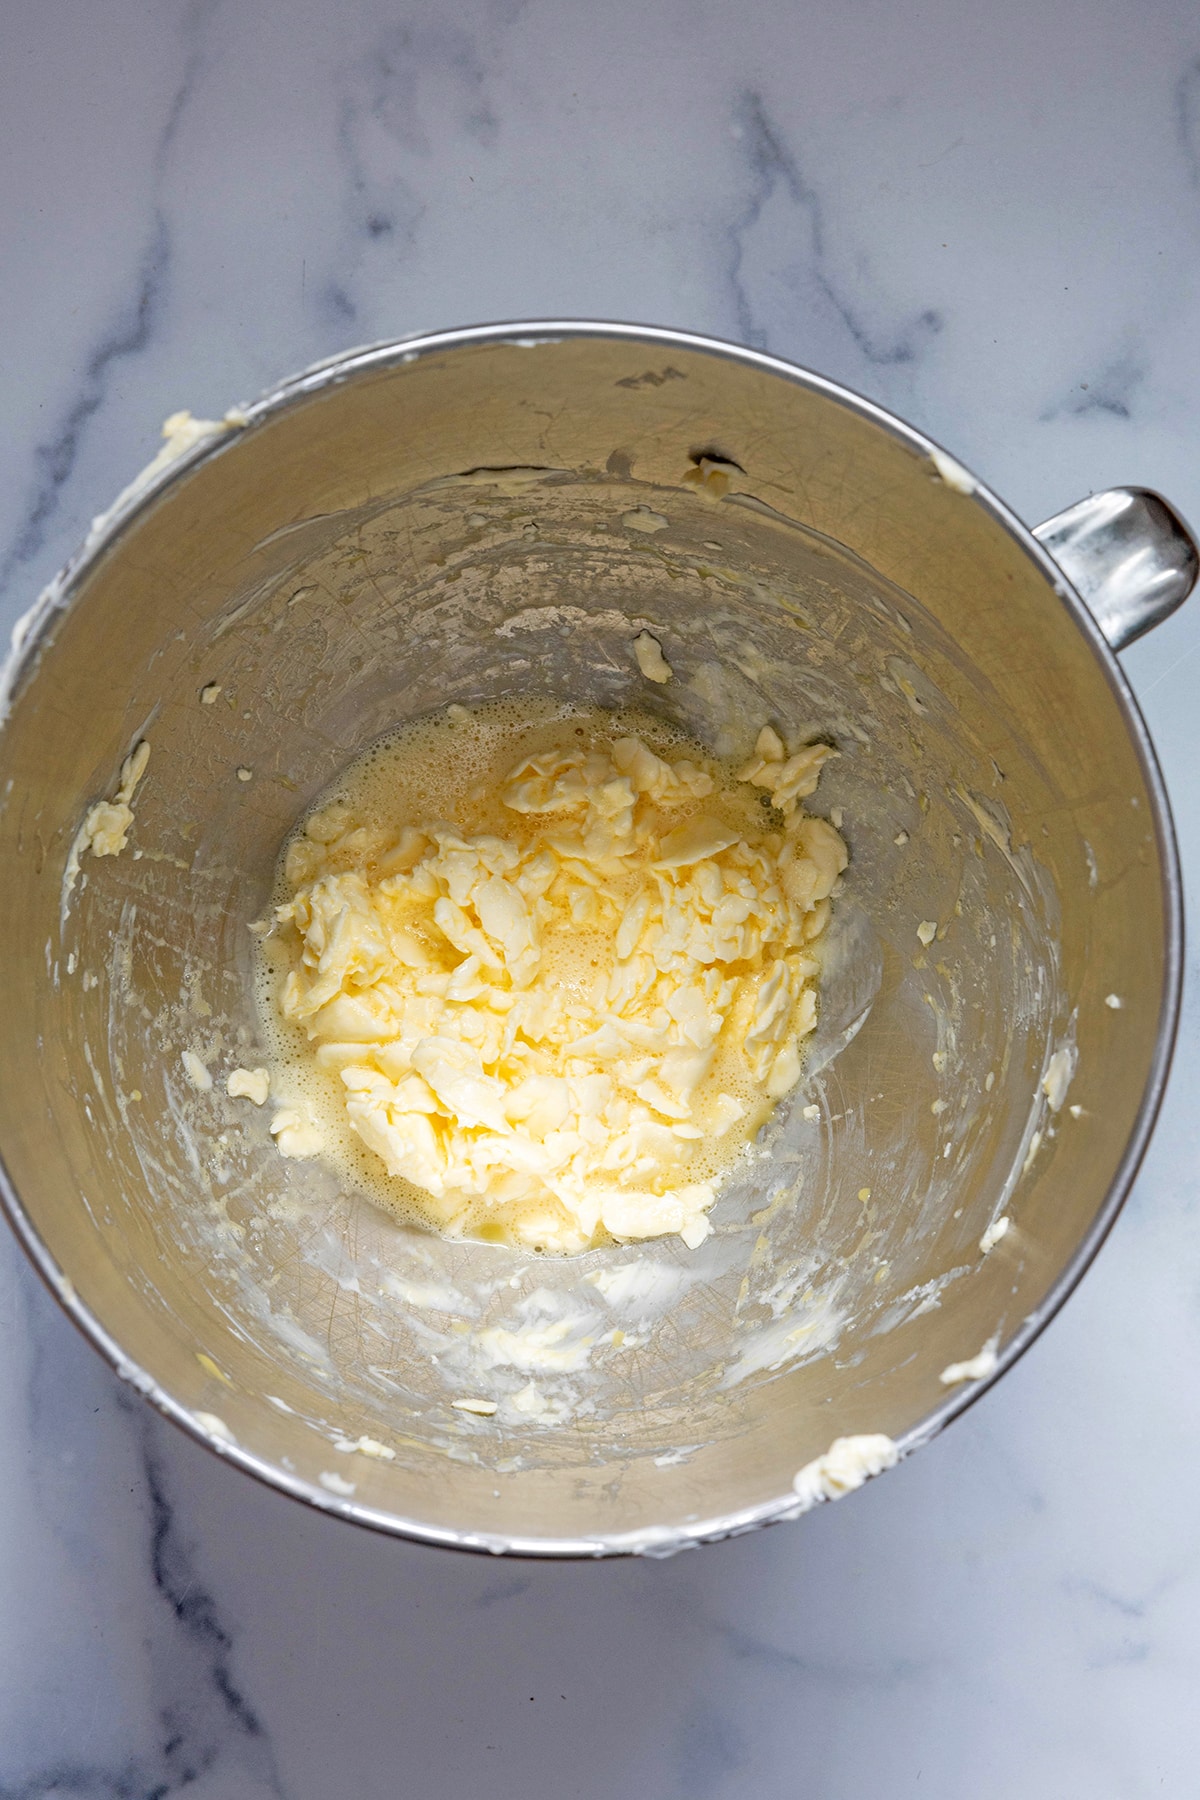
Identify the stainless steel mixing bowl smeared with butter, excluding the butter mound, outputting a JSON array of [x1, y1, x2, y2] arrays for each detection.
[[0, 324, 1195, 1555]]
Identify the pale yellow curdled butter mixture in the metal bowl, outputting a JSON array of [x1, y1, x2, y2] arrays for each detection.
[[261, 702, 846, 1253]]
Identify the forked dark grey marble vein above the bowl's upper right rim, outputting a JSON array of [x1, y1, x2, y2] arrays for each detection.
[[729, 90, 945, 367]]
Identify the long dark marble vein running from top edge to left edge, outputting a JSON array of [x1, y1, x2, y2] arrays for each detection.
[[0, 0, 219, 596]]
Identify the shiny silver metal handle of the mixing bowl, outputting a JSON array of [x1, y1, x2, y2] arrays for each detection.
[[1033, 488, 1200, 650]]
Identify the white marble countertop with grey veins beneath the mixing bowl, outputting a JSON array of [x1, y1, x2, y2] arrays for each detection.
[[0, 0, 1200, 1800]]
